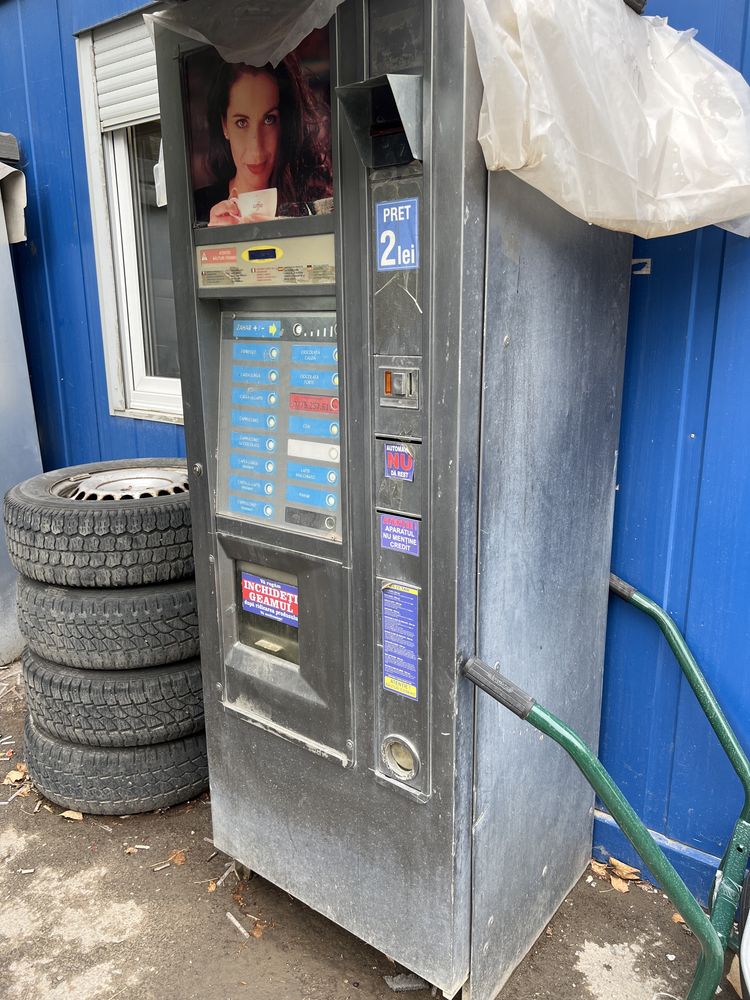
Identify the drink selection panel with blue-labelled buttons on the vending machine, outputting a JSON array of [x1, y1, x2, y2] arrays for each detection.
[[217, 312, 341, 542]]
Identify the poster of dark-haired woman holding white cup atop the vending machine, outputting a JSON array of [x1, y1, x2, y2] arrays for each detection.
[[184, 29, 333, 227]]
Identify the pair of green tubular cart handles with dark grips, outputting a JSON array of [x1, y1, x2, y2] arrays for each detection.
[[463, 575, 750, 1000]]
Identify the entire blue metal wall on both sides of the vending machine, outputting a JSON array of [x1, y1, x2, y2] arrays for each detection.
[[0, 0, 750, 908]]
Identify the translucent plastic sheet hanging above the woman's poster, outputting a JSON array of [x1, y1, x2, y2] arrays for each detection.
[[143, 0, 342, 66]]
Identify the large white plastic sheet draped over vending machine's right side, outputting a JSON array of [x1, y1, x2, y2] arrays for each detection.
[[464, 0, 750, 237]]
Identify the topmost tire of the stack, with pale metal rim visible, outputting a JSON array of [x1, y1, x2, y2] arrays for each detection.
[[3, 458, 193, 587]]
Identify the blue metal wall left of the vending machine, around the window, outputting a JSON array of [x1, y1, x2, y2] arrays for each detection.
[[0, 0, 185, 469]]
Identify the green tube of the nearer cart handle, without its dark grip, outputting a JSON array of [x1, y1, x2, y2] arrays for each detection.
[[525, 704, 736, 1000]]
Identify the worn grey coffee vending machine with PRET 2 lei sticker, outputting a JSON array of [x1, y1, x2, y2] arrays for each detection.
[[156, 0, 631, 1000]]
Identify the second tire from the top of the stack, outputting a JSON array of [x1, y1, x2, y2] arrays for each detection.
[[18, 577, 199, 670]]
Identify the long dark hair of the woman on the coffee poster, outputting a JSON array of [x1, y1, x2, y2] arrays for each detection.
[[208, 53, 333, 215]]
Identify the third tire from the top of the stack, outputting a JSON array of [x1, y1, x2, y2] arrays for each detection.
[[23, 649, 204, 747]]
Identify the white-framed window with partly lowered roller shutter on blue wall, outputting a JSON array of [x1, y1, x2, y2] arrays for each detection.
[[78, 15, 182, 421]]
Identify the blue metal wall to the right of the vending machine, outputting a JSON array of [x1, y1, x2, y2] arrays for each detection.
[[594, 0, 750, 900]]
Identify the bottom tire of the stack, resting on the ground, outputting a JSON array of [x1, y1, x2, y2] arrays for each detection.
[[25, 715, 208, 816]]
